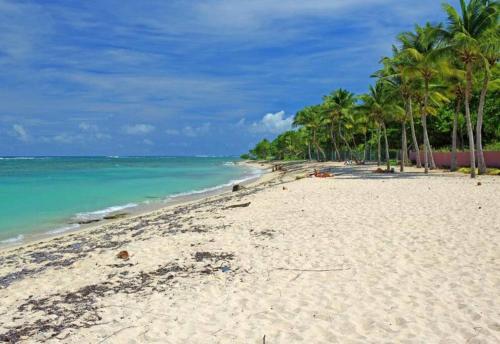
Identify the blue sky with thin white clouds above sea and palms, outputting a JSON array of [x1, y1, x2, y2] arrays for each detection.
[[0, 0, 457, 156]]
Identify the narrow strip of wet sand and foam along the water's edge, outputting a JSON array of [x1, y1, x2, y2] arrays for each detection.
[[0, 161, 268, 253]]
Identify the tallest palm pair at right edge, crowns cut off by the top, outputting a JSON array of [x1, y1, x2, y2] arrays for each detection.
[[443, 0, 499, 178]]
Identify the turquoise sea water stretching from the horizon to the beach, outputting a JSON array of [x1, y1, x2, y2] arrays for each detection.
[[0, 157, 255, 244]]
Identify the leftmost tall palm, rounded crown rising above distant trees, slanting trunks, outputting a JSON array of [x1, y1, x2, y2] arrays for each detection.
[[323, 89, 355, 163]]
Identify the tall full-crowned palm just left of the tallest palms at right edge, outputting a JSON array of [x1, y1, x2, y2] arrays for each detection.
[[398, 23, 442, 173]]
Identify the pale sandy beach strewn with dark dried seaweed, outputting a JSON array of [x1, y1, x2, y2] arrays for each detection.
[[0, 163, 500, 343]]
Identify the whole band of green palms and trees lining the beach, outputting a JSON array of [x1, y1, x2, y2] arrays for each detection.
[[242, 0, 500, 177]]
